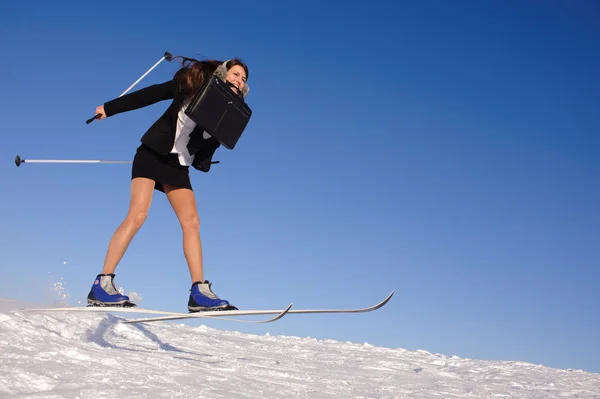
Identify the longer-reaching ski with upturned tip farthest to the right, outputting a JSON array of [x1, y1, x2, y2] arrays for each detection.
[[120, 291, 394, 323]]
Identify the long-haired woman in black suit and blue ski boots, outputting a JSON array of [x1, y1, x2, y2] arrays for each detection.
[[88, 57, 249, 312]]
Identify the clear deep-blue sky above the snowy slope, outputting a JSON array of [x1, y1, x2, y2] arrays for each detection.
[[0, 0, 600, 372]]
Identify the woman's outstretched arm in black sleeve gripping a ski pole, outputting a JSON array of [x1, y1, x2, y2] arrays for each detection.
[[96, 80, 177, 119]]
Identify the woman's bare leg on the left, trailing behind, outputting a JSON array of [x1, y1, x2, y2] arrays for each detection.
[[102, 177, 154, 274]]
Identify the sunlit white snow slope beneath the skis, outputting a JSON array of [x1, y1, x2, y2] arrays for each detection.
[[0, 299, 600, 399]]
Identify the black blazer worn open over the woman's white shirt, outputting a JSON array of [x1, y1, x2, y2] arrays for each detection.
[[104, 79, 221, 172]]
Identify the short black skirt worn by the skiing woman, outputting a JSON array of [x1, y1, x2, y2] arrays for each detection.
[[131, 144, 192, 193]]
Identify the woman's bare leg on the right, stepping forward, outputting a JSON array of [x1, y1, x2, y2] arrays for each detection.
[[164, 184, 204, 283]]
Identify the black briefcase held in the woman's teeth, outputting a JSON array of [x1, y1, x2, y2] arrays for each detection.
[[185, 75, 252, 150]]
